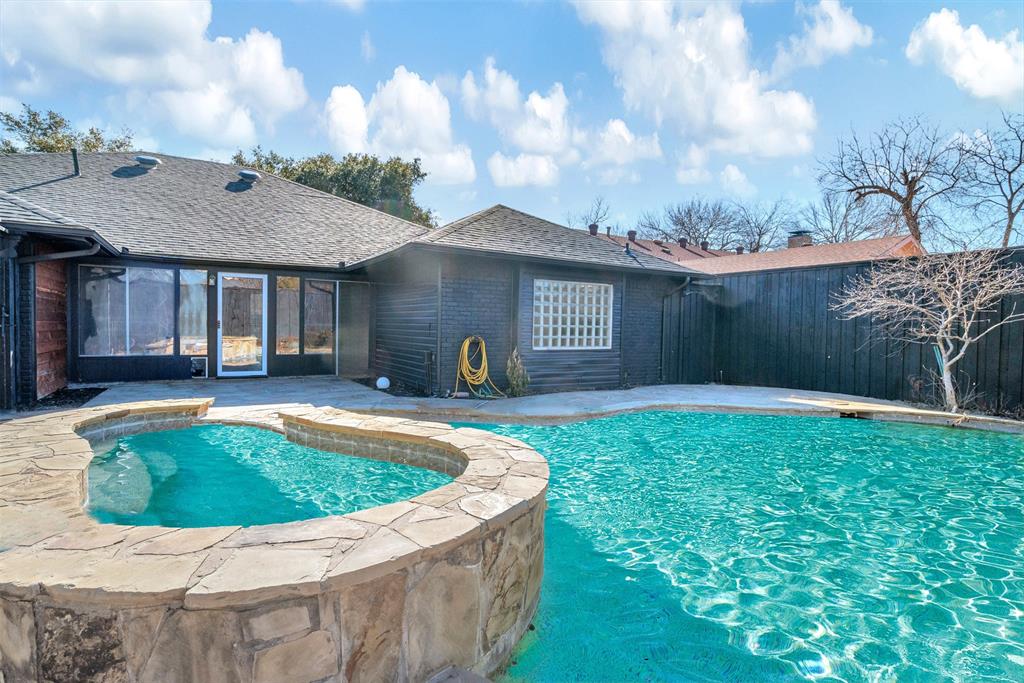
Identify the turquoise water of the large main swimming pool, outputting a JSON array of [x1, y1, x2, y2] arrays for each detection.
[[468, 412, 1024, 682]]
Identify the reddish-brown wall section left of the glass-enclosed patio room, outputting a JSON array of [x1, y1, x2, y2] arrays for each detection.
[[35, 261, 68, 398]]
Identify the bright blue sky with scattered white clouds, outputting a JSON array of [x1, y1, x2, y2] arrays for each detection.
[[0, 0, 1024, 229]]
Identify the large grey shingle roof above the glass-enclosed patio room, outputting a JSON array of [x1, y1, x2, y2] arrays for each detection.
[[0, 153, 429, 268]]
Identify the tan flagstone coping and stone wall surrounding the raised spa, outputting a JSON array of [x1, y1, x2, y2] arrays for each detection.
[[0, 400, 548, 683]]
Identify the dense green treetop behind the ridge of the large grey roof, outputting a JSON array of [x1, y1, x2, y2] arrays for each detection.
[[231, 146, 436, 227]]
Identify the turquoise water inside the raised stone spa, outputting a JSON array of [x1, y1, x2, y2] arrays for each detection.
[[89, 425, 452, 526]]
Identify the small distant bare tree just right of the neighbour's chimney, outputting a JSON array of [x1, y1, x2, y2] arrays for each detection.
[[797, 191, 899, 244]]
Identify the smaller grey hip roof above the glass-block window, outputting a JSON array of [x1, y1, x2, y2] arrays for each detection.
[[415, 204, 692, 275]]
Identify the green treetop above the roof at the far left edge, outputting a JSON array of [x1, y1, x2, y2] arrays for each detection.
[[0, 104, 132, 155]]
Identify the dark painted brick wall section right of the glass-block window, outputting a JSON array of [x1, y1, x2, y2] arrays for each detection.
[[622, 275, 676, 386]]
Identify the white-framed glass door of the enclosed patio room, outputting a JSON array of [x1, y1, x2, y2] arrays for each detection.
[[217, 272, 266, 377]]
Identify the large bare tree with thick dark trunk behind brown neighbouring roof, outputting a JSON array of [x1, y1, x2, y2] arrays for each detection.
[[818, 117, 967, 241]]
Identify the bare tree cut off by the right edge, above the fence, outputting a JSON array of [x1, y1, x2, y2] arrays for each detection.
[[962, 114, 1024, 248]]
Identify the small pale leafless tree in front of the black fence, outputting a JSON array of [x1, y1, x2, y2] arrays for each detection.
[[831, 250, 1024, 411]]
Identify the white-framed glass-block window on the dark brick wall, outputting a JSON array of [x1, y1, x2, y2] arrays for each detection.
[[534, 280, 613, 350]]
